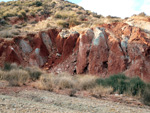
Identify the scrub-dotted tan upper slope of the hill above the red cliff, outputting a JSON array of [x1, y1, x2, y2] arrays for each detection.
[[0, 0, 122, 38]]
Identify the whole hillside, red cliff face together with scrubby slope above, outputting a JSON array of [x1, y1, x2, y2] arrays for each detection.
[[0, 0, 150, 81]]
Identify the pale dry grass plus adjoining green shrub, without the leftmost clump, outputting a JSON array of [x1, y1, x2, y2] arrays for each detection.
[[31, 73, 150, 105]]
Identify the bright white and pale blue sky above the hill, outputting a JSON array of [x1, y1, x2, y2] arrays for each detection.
[[0, 0, 150, 18]]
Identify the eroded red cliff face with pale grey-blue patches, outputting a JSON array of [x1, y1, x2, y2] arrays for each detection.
[[0, 23, 150, 81]]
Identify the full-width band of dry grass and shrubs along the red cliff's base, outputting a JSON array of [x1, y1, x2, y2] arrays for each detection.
[[0, 63, 150, 105]]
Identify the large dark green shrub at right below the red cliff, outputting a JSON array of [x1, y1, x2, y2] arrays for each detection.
[[96, 74, 146, 97]]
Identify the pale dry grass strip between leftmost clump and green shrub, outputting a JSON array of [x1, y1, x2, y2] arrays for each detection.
[[34, 73, 113, 98]]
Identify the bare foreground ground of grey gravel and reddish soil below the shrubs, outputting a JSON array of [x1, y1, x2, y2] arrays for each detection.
[[0, 81, 150, 113]]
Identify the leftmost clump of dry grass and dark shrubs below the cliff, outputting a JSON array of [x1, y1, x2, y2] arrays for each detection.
[[0, 63, 44, 86]]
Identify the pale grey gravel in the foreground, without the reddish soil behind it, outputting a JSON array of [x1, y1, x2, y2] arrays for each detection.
[[0, 90, 150, 113]]
